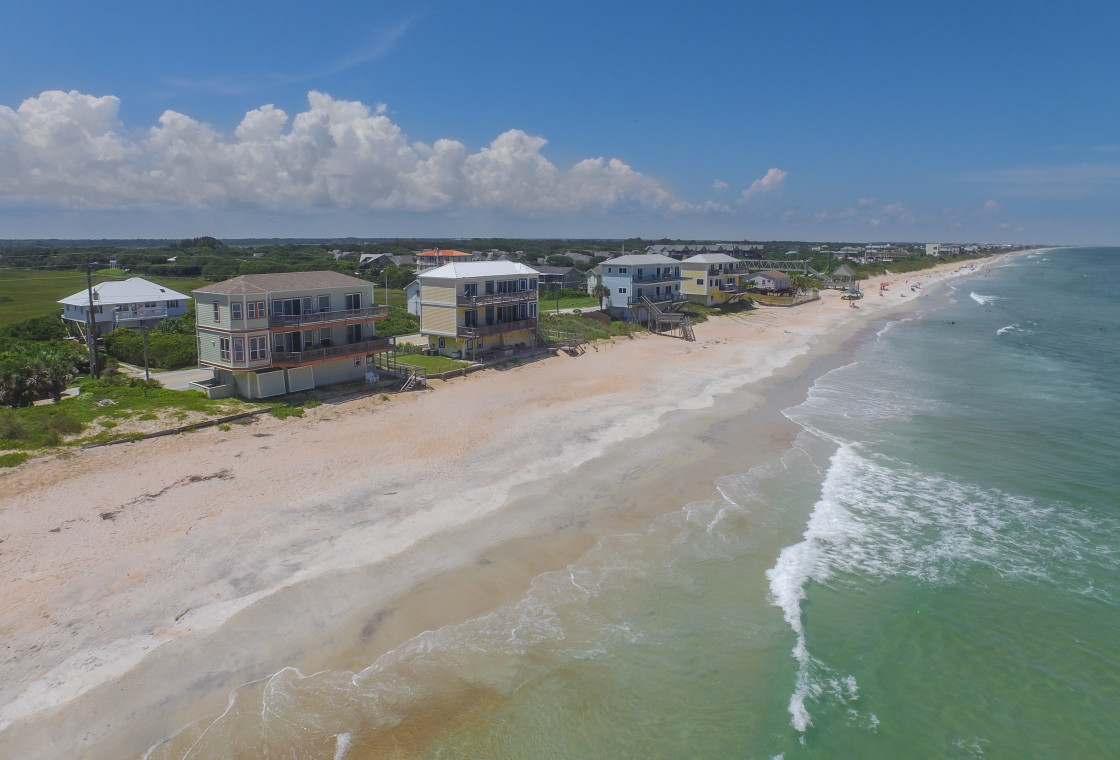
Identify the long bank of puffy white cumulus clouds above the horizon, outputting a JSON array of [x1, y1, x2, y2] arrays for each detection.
[[0, 91, 680, 215]]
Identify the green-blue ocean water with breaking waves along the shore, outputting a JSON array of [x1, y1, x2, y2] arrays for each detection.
[[146, 248, 1120, 760]]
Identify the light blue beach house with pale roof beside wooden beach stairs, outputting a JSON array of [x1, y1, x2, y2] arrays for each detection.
[[601, 253, 684, 322]]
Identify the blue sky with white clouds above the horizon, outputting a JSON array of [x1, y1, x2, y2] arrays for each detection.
[[0, 0, 1120, 244]]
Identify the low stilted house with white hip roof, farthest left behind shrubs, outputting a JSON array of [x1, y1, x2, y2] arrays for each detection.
[[58, 278, 190, 334]]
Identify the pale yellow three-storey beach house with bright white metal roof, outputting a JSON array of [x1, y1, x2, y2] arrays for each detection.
[[417, 261, 540, 359]]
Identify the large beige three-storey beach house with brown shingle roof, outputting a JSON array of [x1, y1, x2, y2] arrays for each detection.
[[192, 272, 394, 398]]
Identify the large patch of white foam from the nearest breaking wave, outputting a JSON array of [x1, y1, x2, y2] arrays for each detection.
[[766, 444, 1120, 732]]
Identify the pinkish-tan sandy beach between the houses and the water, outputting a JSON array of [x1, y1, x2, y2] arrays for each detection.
[[0, 260, 1008, 759]]
